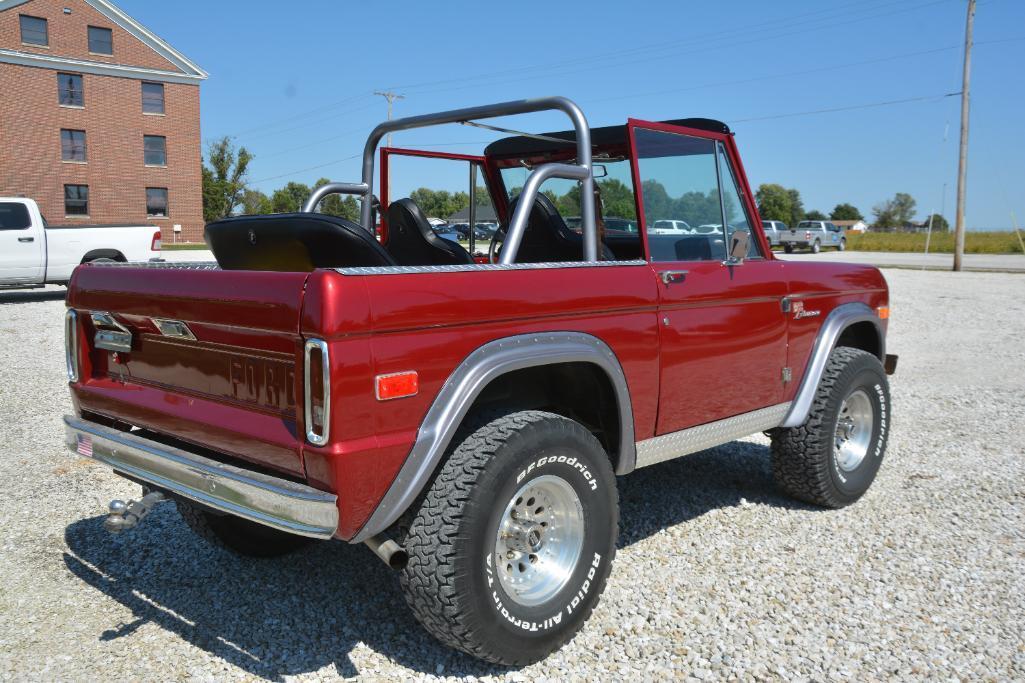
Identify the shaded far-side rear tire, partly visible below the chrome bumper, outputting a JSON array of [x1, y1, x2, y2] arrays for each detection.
[[174, 498, 314, 558]]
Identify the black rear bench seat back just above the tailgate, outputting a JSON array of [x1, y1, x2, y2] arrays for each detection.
[[205, 213, 396, 272]]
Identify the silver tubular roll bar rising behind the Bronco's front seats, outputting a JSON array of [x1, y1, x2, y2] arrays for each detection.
[[302, 97, 598, 264]]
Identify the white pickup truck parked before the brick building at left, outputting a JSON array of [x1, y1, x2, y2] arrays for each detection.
[[0, 197, 160, 289]]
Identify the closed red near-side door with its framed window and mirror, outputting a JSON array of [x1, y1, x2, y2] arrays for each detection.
[[629, 121, 787, 434]]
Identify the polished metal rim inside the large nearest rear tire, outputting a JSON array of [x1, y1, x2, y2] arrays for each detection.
[[495, 475, 584, 606]]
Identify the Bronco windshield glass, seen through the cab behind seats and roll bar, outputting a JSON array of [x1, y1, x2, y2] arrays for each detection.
[[501, 158, 638, 223]]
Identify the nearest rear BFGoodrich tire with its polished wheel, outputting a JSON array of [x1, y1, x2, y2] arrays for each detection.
[[401, 410, 619, 666]]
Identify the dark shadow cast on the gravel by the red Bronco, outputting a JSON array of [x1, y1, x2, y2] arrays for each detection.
[[65, 442, 803, 680]]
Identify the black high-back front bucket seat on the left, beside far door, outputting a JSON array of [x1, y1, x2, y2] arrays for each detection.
[[384, 199, 474, 266]]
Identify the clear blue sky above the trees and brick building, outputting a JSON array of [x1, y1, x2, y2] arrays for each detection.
[[119, 0, 1025, 229]]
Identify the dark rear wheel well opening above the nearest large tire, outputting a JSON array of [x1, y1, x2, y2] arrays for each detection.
[[466, 362, 622, 468]]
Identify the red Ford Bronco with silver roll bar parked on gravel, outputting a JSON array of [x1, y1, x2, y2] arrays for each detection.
[[65, 97, 896, 665]]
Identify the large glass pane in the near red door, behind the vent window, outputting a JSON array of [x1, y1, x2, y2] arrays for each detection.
[[634, 128, 726, 262]]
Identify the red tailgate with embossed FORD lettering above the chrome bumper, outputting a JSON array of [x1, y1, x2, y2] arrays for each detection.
[[68, 264, 309, 475]]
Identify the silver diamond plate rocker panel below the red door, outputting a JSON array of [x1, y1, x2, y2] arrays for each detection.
[[637, 402, 790, 468]]
